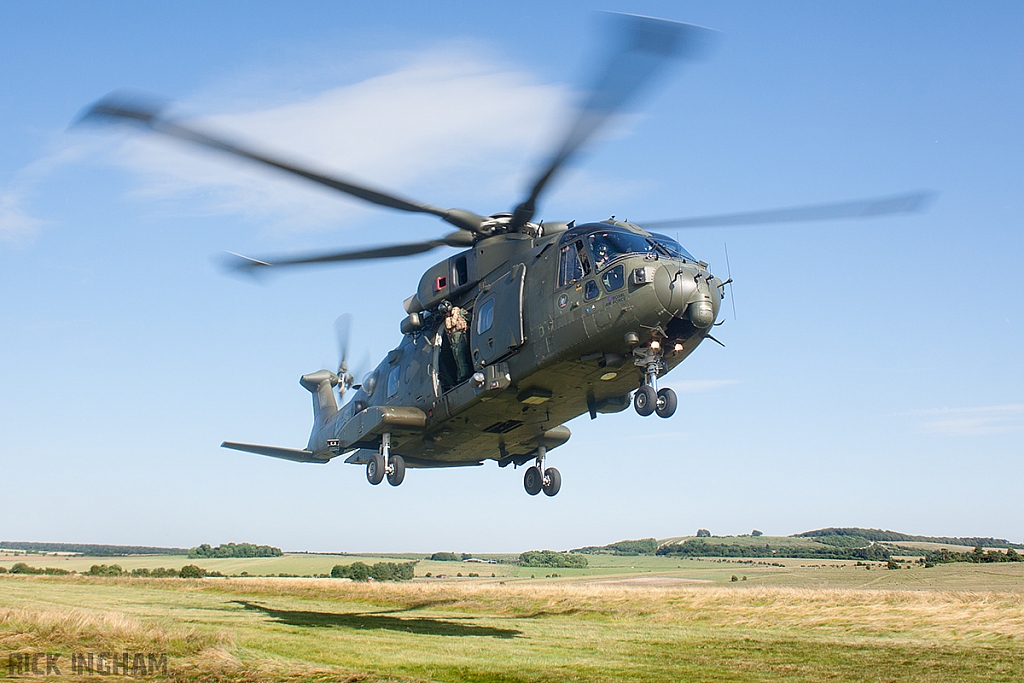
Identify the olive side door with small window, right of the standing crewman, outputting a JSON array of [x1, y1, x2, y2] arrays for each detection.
[[472, 263, 526, 368]]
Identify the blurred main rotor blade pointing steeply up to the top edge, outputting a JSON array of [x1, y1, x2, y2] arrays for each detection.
[[509, 14, 715, 230]]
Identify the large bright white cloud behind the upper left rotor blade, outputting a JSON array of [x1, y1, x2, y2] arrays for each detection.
[[102, 51, 585, 233]]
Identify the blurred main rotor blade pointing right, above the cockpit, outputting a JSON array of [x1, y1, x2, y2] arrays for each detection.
[[639, 191, 936, 229]]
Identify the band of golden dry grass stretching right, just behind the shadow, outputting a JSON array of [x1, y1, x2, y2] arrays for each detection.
[[197, 579, 1024, 642]]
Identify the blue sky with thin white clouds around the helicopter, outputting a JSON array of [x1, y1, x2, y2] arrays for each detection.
[[0, 0, 1024, 552]]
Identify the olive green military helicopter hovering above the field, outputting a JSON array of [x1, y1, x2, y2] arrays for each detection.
[[83, 14, 929, 496]]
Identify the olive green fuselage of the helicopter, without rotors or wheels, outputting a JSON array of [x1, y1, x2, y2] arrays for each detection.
[[307, 221, 722, 467]]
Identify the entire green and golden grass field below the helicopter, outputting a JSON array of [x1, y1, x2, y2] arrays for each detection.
[[0, 555, 1024, 683]]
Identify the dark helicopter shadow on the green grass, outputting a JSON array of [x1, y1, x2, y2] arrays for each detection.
[[231, 600, 522, 638]]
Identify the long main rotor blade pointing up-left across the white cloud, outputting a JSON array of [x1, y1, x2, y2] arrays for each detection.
[[80, 95, 484, 231]]
